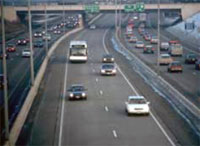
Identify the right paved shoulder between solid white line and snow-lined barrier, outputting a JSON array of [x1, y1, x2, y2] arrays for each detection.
[[106, 28, 199, 145]]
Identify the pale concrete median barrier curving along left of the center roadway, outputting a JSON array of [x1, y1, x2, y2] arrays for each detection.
[[5, 24, 84, 146]]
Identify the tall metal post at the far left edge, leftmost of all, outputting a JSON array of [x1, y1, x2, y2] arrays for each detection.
[[1, 0, 9, 142]]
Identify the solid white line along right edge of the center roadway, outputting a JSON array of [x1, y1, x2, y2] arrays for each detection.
[[103, 29, 176, 146]]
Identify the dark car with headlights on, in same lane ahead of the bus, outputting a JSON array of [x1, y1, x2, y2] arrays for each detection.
[[68, 84, 87, 100]]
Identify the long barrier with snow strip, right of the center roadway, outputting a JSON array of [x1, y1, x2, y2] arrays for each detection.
[[112, 28, 200, 137]]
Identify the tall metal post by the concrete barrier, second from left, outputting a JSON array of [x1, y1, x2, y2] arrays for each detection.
[[28, 0, 35, 86]]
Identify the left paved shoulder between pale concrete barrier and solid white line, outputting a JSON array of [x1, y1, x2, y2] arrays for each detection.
[[28, 36, 69, 145]]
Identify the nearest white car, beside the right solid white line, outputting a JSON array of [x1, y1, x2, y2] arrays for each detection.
[[125, 96, 150, 115]]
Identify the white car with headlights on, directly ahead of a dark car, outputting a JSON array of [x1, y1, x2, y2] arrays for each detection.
[[101, 64, 117, 75]]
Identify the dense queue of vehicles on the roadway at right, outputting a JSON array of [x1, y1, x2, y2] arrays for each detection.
[[125, 20, 200, 72]]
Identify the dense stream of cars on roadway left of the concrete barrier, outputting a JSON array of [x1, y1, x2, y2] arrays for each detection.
[[0, 15, 79, 89]]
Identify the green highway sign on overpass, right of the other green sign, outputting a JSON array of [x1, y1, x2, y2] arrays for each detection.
[[124, 3, 145, 13]]
